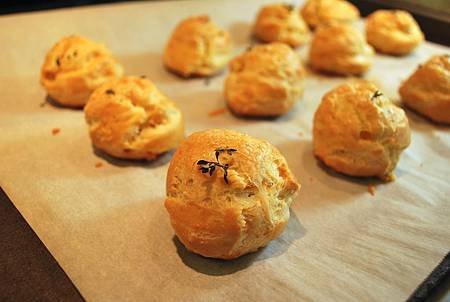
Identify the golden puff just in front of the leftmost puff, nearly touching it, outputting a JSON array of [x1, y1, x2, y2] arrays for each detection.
[[84, 77, 184, 160]]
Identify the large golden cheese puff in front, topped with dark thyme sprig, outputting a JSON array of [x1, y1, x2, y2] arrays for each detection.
[[165, 129, 300, 259]]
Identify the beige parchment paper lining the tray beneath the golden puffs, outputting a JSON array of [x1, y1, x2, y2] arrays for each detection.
[[0, 0, 450, 301]]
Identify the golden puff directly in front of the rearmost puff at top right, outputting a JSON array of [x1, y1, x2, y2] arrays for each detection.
[[309, 24, 374, 75]]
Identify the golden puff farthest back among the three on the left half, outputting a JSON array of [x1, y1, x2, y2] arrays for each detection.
[[163, 16, 232, 77]]
